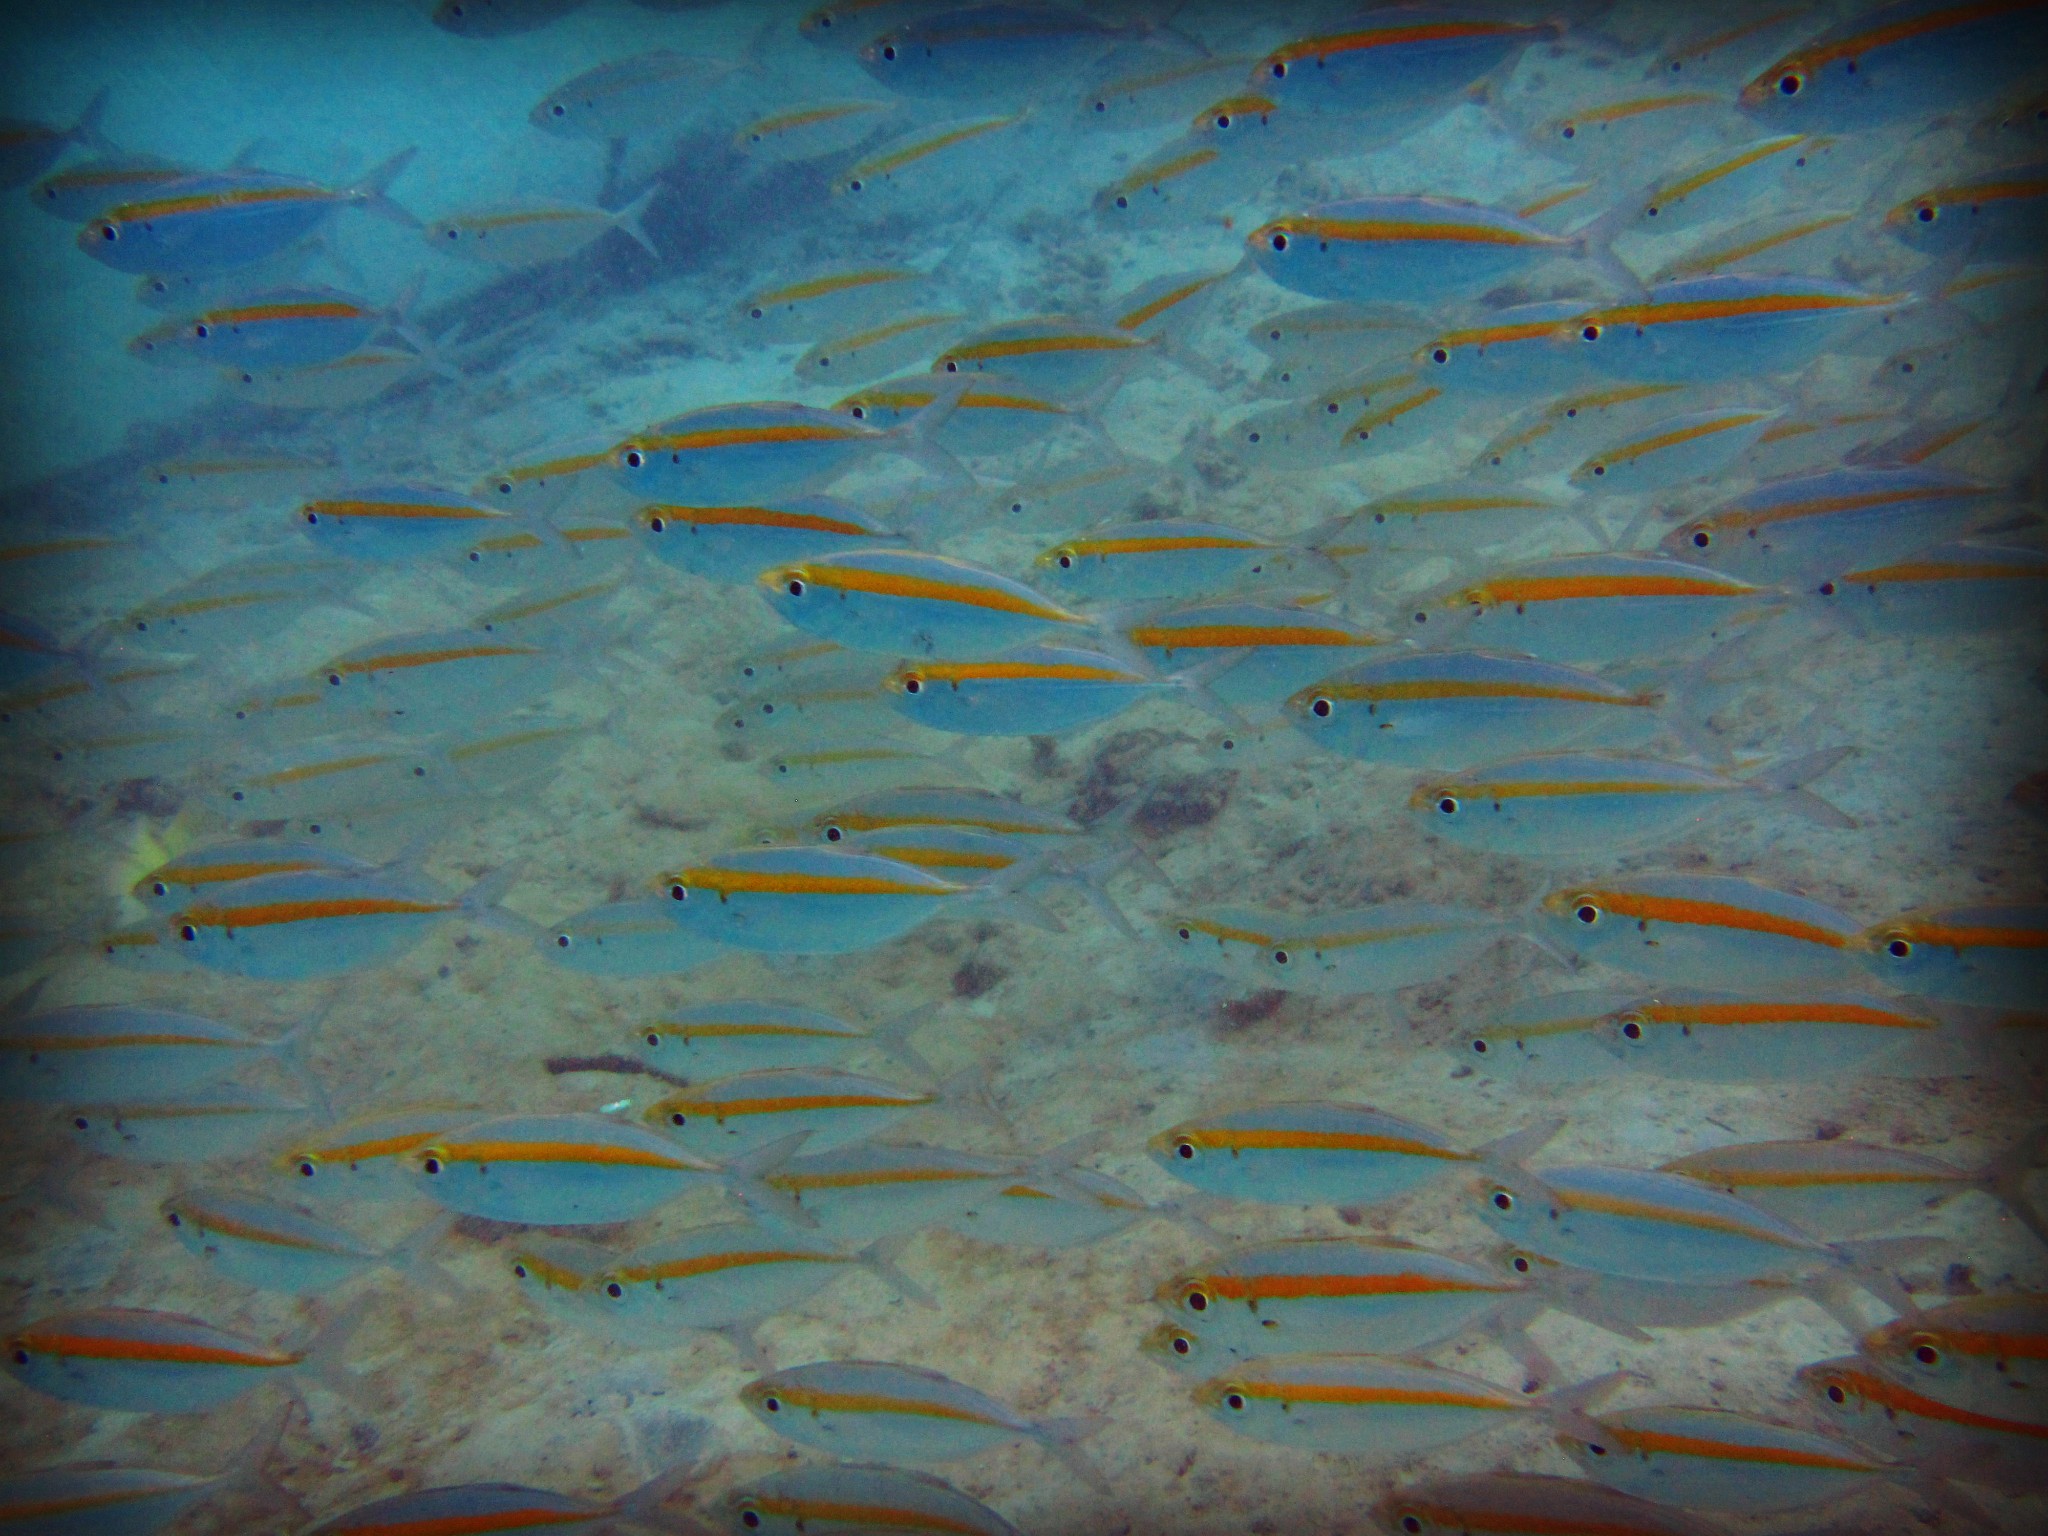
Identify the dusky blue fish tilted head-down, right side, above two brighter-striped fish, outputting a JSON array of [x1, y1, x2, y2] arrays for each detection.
[[1663, 465, 1999, 580]]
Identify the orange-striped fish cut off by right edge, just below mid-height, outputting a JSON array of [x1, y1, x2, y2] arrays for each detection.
[[1862, 905, 2048, 1010]]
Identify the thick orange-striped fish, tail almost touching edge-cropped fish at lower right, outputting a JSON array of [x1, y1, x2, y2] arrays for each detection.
[[1542, 874, 1862, 987]]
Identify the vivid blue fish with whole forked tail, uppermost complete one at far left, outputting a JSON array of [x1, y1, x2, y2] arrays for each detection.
[[78, 150, 418, 274]]
